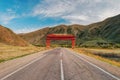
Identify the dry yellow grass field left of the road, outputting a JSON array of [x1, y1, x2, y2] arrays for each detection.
[[0, 43, 45, 63]]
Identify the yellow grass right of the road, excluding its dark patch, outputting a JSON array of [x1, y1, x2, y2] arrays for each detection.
[[74, 48, 120, 67]]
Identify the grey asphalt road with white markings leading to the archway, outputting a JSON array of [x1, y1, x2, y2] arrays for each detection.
[[0, 48, 120, 80]]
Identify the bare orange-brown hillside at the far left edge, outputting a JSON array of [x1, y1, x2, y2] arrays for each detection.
[[0, 25, 29, 46]]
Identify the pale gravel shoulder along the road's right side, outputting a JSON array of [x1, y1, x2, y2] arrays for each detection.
[[67, 49, 120, 76]]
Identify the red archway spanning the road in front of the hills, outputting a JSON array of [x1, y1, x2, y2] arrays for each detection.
[[46, 34, 75, 48]]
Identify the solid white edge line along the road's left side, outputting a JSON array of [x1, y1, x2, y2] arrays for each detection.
[[0, 55, 46, 80]]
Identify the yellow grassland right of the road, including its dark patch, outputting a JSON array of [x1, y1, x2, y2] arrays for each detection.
[[74, 48, 120, 67]]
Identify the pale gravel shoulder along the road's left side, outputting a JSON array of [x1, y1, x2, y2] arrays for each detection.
[[0, 50, 50, 78]]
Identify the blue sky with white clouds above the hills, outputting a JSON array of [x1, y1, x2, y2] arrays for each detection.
[[0, 0, 120, 33]]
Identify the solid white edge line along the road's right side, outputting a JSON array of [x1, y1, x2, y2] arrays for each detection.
[[72, 53, 120, 80]]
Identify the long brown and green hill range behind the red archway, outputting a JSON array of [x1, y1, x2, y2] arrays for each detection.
[[19, 15, 120, 47]]
